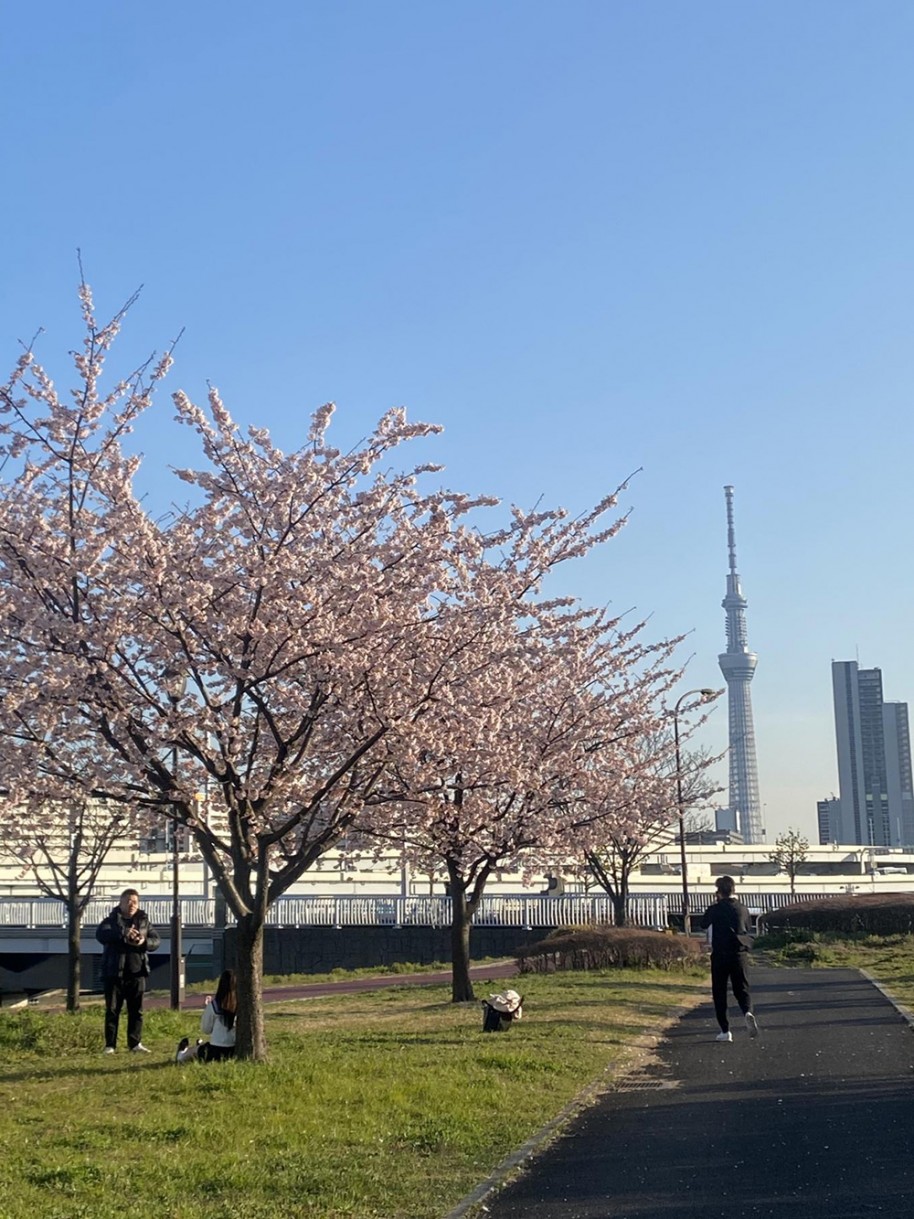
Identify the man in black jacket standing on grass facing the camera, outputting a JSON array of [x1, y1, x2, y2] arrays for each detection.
[[95, 889, 160, 1054]]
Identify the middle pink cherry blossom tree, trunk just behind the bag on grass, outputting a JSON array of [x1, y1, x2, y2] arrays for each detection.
[[360, 575, 679, 1002]]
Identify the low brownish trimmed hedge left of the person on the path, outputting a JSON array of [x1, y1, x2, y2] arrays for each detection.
[[517, 926, 704, 974]]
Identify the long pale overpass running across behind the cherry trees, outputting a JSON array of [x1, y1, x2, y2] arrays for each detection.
[[0, 840, 914, 990]]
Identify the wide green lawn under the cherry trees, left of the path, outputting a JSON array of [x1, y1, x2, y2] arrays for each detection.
[[0, 970, 707, 1219]]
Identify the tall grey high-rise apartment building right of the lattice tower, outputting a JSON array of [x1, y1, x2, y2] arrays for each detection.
[[829, 661, 914, 846]]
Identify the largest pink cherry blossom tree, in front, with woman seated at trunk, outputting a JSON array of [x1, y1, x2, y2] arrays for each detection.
[[0, 283, 672, 1059]]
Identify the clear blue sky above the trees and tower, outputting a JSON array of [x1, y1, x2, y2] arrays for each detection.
[[0, 0, 914, 839]]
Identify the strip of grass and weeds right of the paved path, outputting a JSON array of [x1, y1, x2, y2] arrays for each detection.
[[756, 931, 914, 1008]]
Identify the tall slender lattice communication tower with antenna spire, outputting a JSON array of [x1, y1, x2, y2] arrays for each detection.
[[718, 486, 764, 842]]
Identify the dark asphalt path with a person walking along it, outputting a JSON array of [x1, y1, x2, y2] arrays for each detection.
[[473, 968, 914, 1219]]
